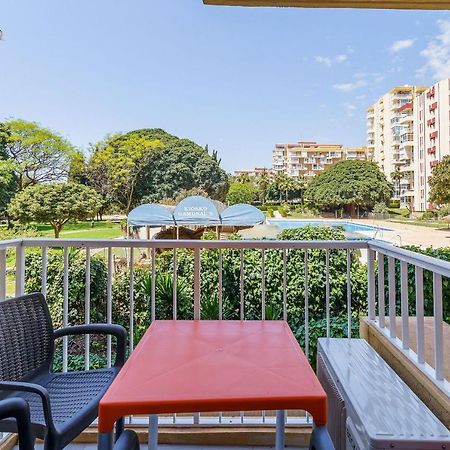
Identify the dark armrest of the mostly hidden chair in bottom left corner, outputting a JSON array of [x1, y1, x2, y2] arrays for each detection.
[[0, 397, 34, 450]]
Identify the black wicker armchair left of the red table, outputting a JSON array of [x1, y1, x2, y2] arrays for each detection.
[[0, 293, 126, 450]]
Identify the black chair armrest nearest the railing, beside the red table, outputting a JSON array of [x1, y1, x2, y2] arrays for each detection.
[[53, 323, 127, 367]]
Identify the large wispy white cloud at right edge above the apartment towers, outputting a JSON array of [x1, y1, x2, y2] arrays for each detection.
[[417, 20, 450, 80]]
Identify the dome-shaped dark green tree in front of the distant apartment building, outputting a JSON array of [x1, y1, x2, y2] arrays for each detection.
[[305, 160, 393, 214]]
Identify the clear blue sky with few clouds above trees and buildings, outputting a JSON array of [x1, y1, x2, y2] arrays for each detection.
[[0, 0, 450, 171]]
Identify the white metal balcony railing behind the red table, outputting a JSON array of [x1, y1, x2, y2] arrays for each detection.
[[0, 239, 450, 424]]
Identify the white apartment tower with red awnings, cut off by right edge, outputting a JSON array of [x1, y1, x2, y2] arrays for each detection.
[[413, 78, 450, 211]]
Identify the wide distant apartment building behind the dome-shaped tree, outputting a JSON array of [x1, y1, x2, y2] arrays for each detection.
[[272, 141, 371, 178]]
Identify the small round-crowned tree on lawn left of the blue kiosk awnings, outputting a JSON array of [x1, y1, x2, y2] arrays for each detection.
[[8, 183, 101, 238]]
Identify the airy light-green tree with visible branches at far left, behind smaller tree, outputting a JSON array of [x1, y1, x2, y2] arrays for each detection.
[[0, 119, 75, 189]]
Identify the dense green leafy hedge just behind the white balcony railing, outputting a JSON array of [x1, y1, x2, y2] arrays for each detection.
[[22, 227, 367, 368]]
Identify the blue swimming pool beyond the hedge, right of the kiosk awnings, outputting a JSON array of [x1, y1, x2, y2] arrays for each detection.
[[267, 219, 390, 237]]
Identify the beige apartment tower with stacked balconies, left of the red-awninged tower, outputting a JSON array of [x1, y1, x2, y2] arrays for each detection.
[[367, 86, 427, 208]]
